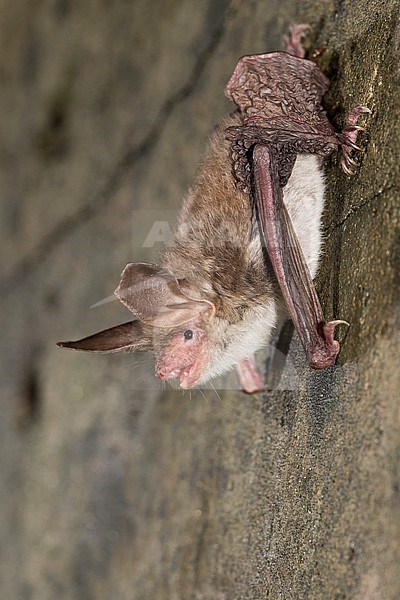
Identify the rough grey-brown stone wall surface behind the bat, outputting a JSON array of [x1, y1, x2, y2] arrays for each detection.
[[0, 0, 400, 600]]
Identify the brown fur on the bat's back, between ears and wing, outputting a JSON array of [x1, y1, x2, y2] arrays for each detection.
[[162, 113, 272, 322]]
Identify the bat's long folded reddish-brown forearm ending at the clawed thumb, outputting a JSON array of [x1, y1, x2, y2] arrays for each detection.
[[253, 144, 343, 369]]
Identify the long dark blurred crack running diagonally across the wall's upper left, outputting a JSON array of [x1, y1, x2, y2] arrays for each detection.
[[0, 2, 239, 293]]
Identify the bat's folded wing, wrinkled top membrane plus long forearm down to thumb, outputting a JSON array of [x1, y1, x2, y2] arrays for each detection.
[[225, 52, 346, 369]]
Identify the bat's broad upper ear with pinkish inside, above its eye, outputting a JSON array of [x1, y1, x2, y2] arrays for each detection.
[[115, 263, 215, 327]]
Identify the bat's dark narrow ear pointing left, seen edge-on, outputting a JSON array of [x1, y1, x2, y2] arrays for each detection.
[[57, 321, 152, 352]]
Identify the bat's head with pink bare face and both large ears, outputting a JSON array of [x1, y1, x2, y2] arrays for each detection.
[[59, 263, 215, 388]]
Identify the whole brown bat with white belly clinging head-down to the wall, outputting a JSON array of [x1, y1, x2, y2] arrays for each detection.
[[59, 25, 369, 393]]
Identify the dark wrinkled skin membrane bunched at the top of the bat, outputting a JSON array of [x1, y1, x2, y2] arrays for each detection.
[[225, 52, 341, 192]]
